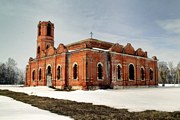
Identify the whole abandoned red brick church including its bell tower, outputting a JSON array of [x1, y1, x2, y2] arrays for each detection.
[[25, 21, 158, 89]]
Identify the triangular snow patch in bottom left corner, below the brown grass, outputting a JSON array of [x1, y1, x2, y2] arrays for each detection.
[[0, 96, 71, 120]]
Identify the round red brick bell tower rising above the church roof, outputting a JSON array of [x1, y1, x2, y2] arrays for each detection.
[[36, 21, 54, 58]]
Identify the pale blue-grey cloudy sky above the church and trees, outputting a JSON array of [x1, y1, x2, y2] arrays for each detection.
[[0, 0, 180, 69]]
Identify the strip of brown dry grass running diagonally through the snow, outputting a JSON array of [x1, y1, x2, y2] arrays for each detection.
[[0, 90, 180, 120]]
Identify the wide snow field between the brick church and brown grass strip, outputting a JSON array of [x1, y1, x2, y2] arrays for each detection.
[[0, 85, 180, 111]]
